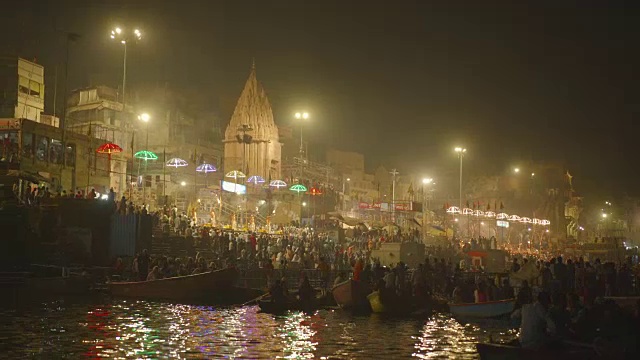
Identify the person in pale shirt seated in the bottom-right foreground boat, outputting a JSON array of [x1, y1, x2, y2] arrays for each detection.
[[511, 291, 556, 349]]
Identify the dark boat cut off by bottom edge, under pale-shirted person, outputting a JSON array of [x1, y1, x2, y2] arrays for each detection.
[[476, 344, 597, 360]]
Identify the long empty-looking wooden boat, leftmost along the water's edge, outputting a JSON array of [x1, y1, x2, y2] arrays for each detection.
[[108, 268, 238, 301]]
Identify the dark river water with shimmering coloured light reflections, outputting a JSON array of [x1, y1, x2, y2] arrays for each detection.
[[0, 300, 516, 359]]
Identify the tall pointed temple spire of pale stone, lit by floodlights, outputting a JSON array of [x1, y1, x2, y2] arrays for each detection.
[[223, 64, 282, 180]]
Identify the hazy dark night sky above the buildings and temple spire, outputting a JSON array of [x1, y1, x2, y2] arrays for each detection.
[[0, 0, 640, 195]]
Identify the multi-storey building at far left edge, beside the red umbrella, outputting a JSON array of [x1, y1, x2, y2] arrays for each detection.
[[0, 58, 109, 192]]
